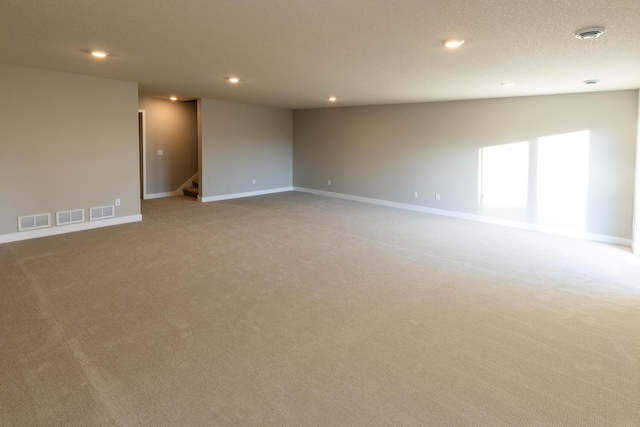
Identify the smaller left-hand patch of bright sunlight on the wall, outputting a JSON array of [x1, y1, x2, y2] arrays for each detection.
[[479, 141, 529, 213]]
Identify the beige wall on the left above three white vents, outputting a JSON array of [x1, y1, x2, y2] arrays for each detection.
[[0, 65, 140, 235]]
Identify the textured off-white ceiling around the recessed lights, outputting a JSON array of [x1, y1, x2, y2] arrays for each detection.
[[0, 0, 640, 108]]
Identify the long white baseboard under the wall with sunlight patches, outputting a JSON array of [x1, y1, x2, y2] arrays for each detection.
[[293, 187, 633, 246]]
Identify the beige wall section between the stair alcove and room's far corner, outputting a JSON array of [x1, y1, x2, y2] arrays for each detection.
[[200, 99, 292, 198]]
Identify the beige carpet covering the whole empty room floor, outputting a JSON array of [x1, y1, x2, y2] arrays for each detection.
[[0, 192, 640, 426]]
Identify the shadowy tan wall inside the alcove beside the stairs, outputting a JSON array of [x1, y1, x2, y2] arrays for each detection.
[[138, 97, 198, 194]]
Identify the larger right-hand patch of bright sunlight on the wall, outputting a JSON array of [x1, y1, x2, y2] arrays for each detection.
[[537, 130, 589, 230]]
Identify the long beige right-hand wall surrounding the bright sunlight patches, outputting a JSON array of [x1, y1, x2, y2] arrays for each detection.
[[294, 91, 638, 238]]
